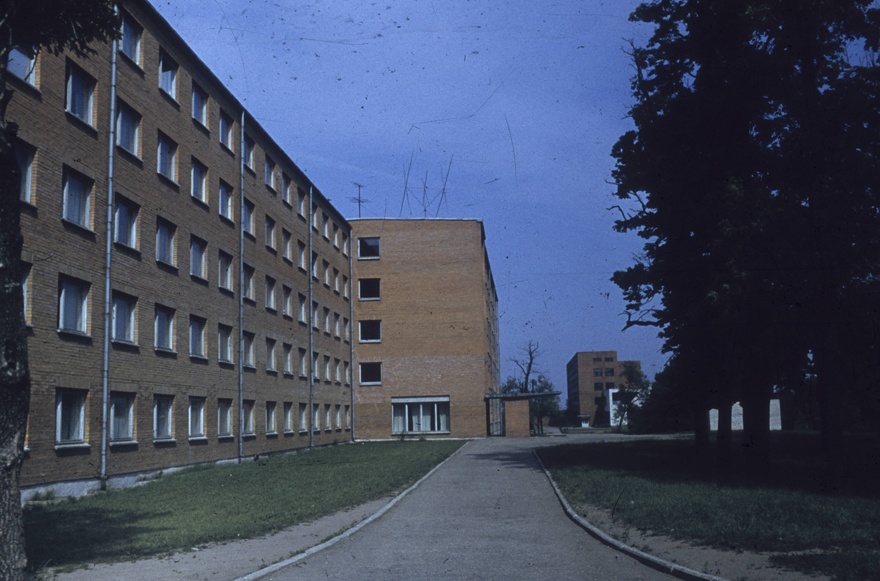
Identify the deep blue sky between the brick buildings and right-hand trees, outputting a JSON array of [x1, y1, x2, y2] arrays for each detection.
[[154, 0, 665, 392]]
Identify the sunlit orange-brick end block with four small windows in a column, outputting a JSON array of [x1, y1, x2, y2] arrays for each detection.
[[351, 219, 501, 438]]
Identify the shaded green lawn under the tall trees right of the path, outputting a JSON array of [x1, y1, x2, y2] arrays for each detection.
[[540, 434, 880, 581]]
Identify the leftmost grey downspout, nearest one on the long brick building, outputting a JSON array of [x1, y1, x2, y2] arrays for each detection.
[[101, 22, 119, 490]]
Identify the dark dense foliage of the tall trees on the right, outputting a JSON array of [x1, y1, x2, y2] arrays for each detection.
[[613, 0, 880, 472]]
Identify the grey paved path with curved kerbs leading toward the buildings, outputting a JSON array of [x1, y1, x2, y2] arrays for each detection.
[[265, 438, 671, 581]]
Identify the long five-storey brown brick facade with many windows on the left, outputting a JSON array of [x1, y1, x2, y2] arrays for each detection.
[[7, 0, 353, 496]]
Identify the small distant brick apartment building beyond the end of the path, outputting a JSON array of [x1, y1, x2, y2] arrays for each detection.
[[566, 351, 641, 426]]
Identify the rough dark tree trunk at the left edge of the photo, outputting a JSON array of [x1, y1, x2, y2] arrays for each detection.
[[0, 84, 30, 580]]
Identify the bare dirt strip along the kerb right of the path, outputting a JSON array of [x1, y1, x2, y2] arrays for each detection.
[[572, 504, 830, 581]]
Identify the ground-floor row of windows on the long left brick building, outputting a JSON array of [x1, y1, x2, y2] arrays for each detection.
[[55, 388, 351, 447]]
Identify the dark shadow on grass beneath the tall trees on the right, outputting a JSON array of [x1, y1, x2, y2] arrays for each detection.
[[539, 432, 880, 498]]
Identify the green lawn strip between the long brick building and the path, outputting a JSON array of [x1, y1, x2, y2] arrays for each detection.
[[25, 441, 462, 569]]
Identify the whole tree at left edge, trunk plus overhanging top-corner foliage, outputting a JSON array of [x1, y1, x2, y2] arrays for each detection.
[[0, 0, 119, 580]]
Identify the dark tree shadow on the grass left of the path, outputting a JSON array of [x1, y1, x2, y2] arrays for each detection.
[[24, 501, 172, 570]]
